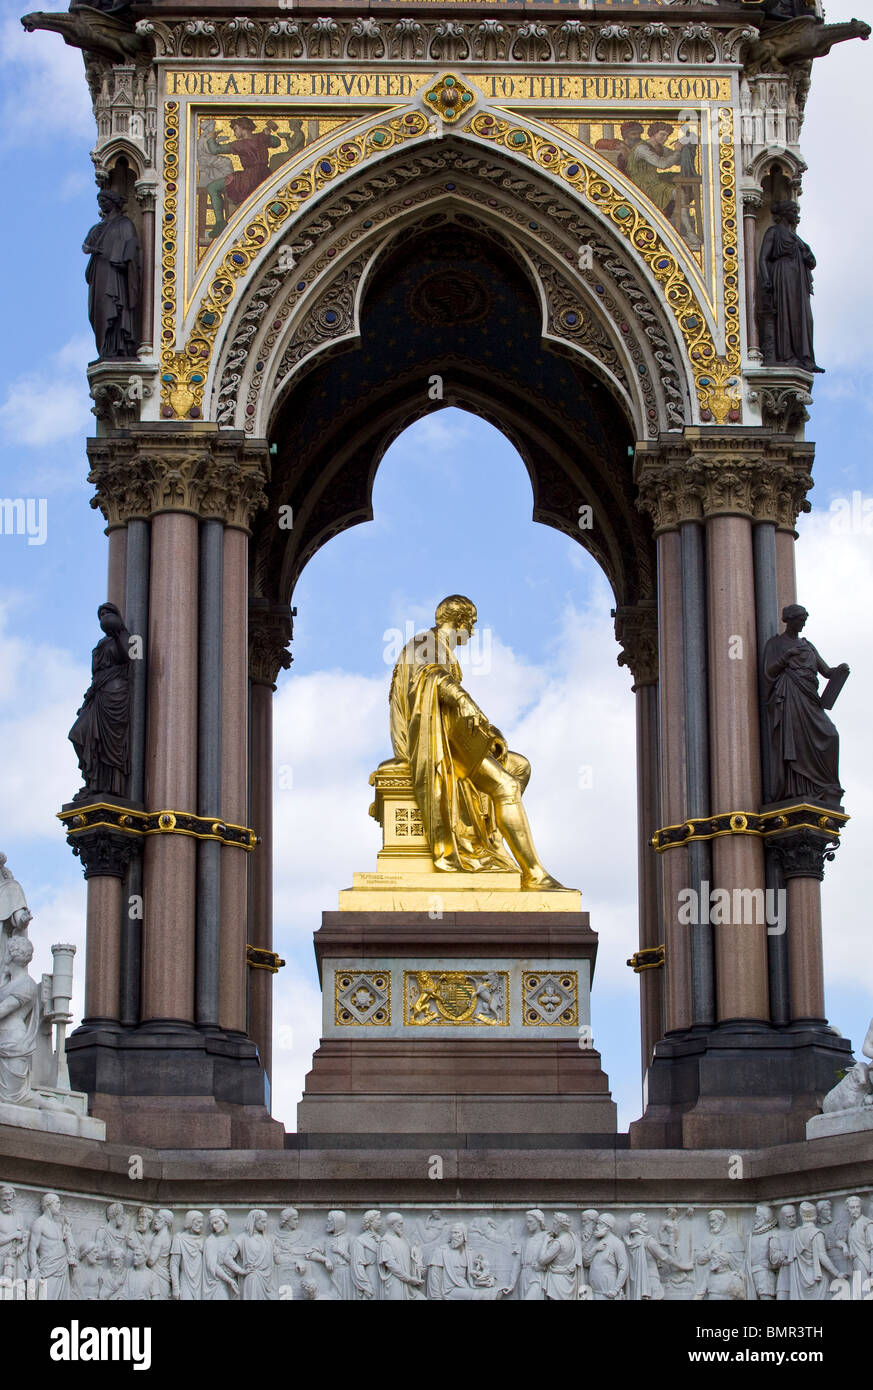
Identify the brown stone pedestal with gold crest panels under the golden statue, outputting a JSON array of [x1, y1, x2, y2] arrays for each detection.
[[297, 911, 616, 1144]]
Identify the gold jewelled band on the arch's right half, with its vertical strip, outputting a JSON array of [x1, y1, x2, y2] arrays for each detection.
[[470, 107, 741, 424]]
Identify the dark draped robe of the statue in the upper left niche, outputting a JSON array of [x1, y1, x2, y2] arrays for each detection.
[[82, 215, 142, 361]]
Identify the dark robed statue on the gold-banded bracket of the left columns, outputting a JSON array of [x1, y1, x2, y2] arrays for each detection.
[[68, 603, 131, 801]]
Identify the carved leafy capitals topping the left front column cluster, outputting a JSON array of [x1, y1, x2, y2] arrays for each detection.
[[88, 425, 270, 531]]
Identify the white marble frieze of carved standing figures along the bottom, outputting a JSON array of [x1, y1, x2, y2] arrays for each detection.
[[0, 1183, 873, 1302]]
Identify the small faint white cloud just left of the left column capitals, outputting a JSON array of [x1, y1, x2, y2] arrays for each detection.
[[0, 335, 96, 448]]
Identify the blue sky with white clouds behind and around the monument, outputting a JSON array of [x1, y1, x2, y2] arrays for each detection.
[[0, 0, 873, 1127]]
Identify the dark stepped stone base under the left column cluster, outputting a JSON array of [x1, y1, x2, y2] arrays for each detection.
[[67, 1019, 285, 1148]]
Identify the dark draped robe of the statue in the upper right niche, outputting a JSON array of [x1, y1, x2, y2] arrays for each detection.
[[758, 222, 816, 371]]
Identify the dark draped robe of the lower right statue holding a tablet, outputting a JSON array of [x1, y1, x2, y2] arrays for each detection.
[[763, 632, 842, 802]]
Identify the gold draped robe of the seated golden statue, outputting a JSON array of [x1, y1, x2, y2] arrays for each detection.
[[389, 631, 519, 872]]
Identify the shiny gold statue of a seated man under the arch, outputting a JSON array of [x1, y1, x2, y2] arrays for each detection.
[[389, 594, 562, 890]]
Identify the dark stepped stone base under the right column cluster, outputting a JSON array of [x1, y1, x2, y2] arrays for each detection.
[[630, 1019, 852, 1150]]
